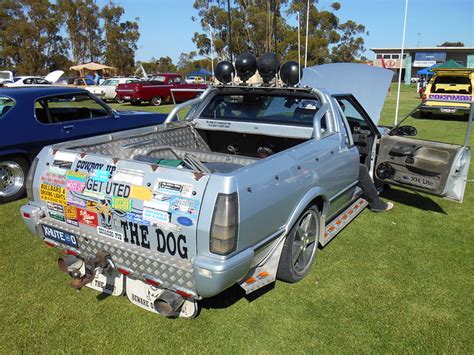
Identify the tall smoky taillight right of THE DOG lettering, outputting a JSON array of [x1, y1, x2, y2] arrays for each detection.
[[210, 192, 239, 255]]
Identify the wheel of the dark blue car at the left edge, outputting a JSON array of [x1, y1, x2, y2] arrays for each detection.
[[0, 157, 29, 204]]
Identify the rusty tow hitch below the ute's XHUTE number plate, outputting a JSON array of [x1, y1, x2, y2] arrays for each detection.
[[58, 251, 113, 290]]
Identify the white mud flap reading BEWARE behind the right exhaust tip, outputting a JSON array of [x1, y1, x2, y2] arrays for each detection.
[[126, 277, 198, 318]]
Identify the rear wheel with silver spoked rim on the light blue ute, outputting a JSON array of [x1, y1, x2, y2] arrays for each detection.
[[277, 206, 321, 283]]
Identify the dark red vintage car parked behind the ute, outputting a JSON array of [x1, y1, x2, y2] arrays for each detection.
[[115, 73, 207, 106]]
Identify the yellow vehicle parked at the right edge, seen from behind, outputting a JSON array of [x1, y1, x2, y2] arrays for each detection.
[[420, 68, 474, 116]]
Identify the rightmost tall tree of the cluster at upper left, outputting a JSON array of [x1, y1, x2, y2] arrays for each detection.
[[100, 2, 140, 73]]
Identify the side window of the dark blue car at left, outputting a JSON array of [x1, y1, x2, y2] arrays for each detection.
[[35, 93, 109, 124]]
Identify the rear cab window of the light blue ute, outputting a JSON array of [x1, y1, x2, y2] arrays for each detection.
[[201, 94, 321, 126]]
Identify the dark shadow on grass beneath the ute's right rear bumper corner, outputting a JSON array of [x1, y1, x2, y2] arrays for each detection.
[[199, 282, 275, 309]]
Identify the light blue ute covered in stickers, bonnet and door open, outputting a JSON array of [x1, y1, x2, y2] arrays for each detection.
[[21, 63, 470, 317]]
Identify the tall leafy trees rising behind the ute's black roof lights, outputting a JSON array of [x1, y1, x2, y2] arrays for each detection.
[[193, 0, 368, 65]]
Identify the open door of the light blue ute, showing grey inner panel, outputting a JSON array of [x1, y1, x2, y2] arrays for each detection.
[[375, 102, 473, 202]]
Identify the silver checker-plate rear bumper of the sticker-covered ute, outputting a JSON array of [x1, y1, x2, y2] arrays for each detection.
[[21, 202, 254, 298]]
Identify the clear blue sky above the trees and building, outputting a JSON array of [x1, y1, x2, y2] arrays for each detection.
[[97, 0, 474, 63]]
